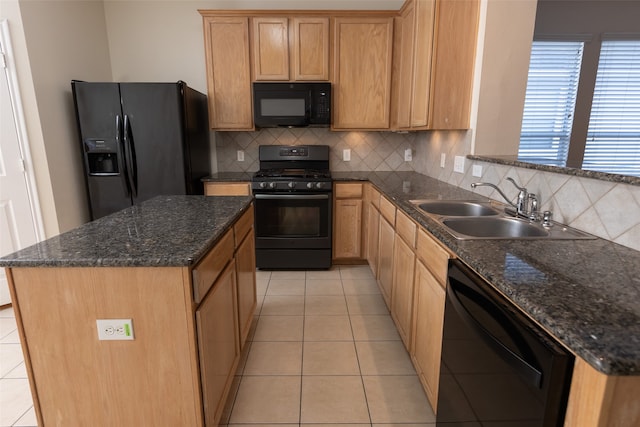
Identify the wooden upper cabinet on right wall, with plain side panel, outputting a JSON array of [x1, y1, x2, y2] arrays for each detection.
[[392, 0, 480, 130]]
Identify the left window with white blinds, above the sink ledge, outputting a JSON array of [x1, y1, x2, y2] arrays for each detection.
[[518, 41, 584, 167]]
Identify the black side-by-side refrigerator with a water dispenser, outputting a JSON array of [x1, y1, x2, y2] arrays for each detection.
[[71, 80, 211, 219]]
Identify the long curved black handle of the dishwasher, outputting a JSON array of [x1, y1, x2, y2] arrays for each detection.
[[447, 278, 542, 388]]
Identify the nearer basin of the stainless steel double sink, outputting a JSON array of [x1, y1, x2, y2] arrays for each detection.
[[442, 217, 550, 239]]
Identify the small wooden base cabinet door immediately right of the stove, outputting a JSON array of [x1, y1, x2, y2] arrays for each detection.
[[333, 199, 362, 259]]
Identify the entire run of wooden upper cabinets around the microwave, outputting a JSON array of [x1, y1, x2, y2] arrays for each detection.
[[200, 0, 480, 130]]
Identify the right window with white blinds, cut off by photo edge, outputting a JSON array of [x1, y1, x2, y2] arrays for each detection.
[[582, 40, 640, 176]]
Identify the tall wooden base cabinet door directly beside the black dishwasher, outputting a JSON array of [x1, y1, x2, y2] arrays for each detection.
[[411, 261, 445, 409]]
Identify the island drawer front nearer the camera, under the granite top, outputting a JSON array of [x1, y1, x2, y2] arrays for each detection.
[[191, 230, 234, 304]]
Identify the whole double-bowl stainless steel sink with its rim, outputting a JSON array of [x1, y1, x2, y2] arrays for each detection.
[[411, 199, 595, 240]]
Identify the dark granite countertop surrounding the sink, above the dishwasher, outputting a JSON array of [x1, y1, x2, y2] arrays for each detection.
[[332, 172, 640, 375]]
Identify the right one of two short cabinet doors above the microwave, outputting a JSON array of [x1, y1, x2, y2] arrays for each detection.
[[291, 17, 329, 81]]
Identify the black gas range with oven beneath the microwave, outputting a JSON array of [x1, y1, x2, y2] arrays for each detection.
[[251, 145, 333, 270]]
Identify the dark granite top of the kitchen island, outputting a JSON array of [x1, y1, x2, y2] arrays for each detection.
[[0, 196, 253, 267]]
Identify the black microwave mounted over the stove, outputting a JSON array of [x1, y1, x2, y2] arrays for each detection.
[[253, 82, 331, 127]]
